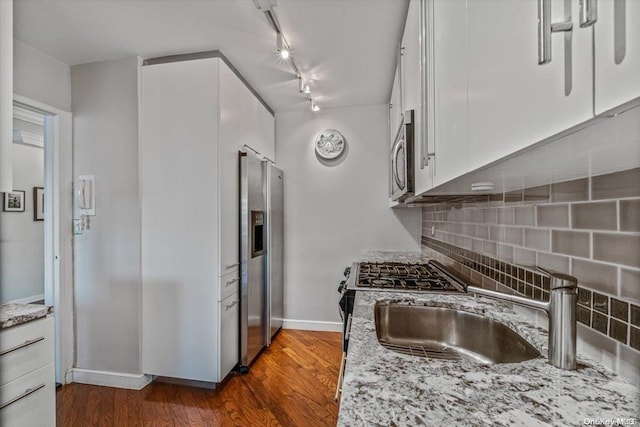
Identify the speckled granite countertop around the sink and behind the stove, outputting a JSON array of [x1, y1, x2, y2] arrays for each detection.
[[338, 252, 640, 426]]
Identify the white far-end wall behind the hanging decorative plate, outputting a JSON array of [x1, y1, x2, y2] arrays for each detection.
[[276, 105, 422, 328]]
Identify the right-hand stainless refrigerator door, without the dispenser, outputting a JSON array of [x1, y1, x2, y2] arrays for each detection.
[[265, 164, 284, 345]]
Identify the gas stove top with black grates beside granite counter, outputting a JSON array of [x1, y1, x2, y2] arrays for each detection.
[[351, 261, 464, 292]]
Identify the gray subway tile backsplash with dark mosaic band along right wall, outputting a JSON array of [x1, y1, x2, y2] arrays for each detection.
[[422, 168, 640, 378]]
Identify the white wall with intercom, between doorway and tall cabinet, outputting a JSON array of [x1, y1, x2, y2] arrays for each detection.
[[71, 57, 142, 374]]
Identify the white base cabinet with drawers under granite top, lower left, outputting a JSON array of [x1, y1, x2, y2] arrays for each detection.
[[0, 317, 56, 427]]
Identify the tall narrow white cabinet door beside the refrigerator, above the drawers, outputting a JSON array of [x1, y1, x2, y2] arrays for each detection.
[[218, 62, 245, 276]]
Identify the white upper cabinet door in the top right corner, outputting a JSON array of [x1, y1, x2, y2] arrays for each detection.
[[593, 0, 640, 114]]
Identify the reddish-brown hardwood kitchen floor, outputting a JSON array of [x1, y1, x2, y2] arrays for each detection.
[[56, 330, 341, 427]]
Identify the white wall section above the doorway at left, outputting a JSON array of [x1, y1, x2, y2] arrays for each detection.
[[13, 39, 71, 111]]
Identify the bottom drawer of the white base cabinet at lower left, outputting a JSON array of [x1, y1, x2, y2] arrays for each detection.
[[0, 363, 56, 427]]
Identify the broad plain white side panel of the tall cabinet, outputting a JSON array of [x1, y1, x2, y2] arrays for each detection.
[[140, 58, 219, 382]]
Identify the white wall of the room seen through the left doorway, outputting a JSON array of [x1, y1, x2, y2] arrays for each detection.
[[0, 120, 44, 302]]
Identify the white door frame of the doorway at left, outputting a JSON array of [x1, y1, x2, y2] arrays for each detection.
[[13, 93, 75, 384]]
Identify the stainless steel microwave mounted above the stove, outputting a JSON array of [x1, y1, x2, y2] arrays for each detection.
[[389, 110, 415, 201]]
